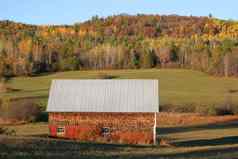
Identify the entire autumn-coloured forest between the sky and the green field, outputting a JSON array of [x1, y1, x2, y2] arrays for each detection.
[[0, 15, 238, 77]]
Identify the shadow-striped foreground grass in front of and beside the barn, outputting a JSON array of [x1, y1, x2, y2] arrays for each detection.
[[0, 121, 238, 159]]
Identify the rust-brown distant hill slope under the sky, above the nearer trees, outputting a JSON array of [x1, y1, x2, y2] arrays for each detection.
[[0, 15, 238, 38]]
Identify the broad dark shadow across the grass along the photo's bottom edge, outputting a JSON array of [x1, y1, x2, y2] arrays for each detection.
[[0, 137, 238, 159]]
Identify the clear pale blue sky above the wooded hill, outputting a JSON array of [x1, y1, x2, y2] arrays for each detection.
[[0, 0, 238, 24]]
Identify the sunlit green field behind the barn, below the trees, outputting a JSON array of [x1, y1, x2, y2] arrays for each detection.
[[0, 69, 238, 106]]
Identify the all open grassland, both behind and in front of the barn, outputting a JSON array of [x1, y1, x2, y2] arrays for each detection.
[[0, 69, 238, 159]]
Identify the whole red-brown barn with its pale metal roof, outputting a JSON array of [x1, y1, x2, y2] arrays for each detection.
[[47, 80, 159, 144]]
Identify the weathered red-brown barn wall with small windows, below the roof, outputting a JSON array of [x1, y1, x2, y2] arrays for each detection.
[[49, 113, 154, 144]]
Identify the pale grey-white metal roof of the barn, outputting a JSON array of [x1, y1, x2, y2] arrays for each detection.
[[47, 80, 159, 112]]
